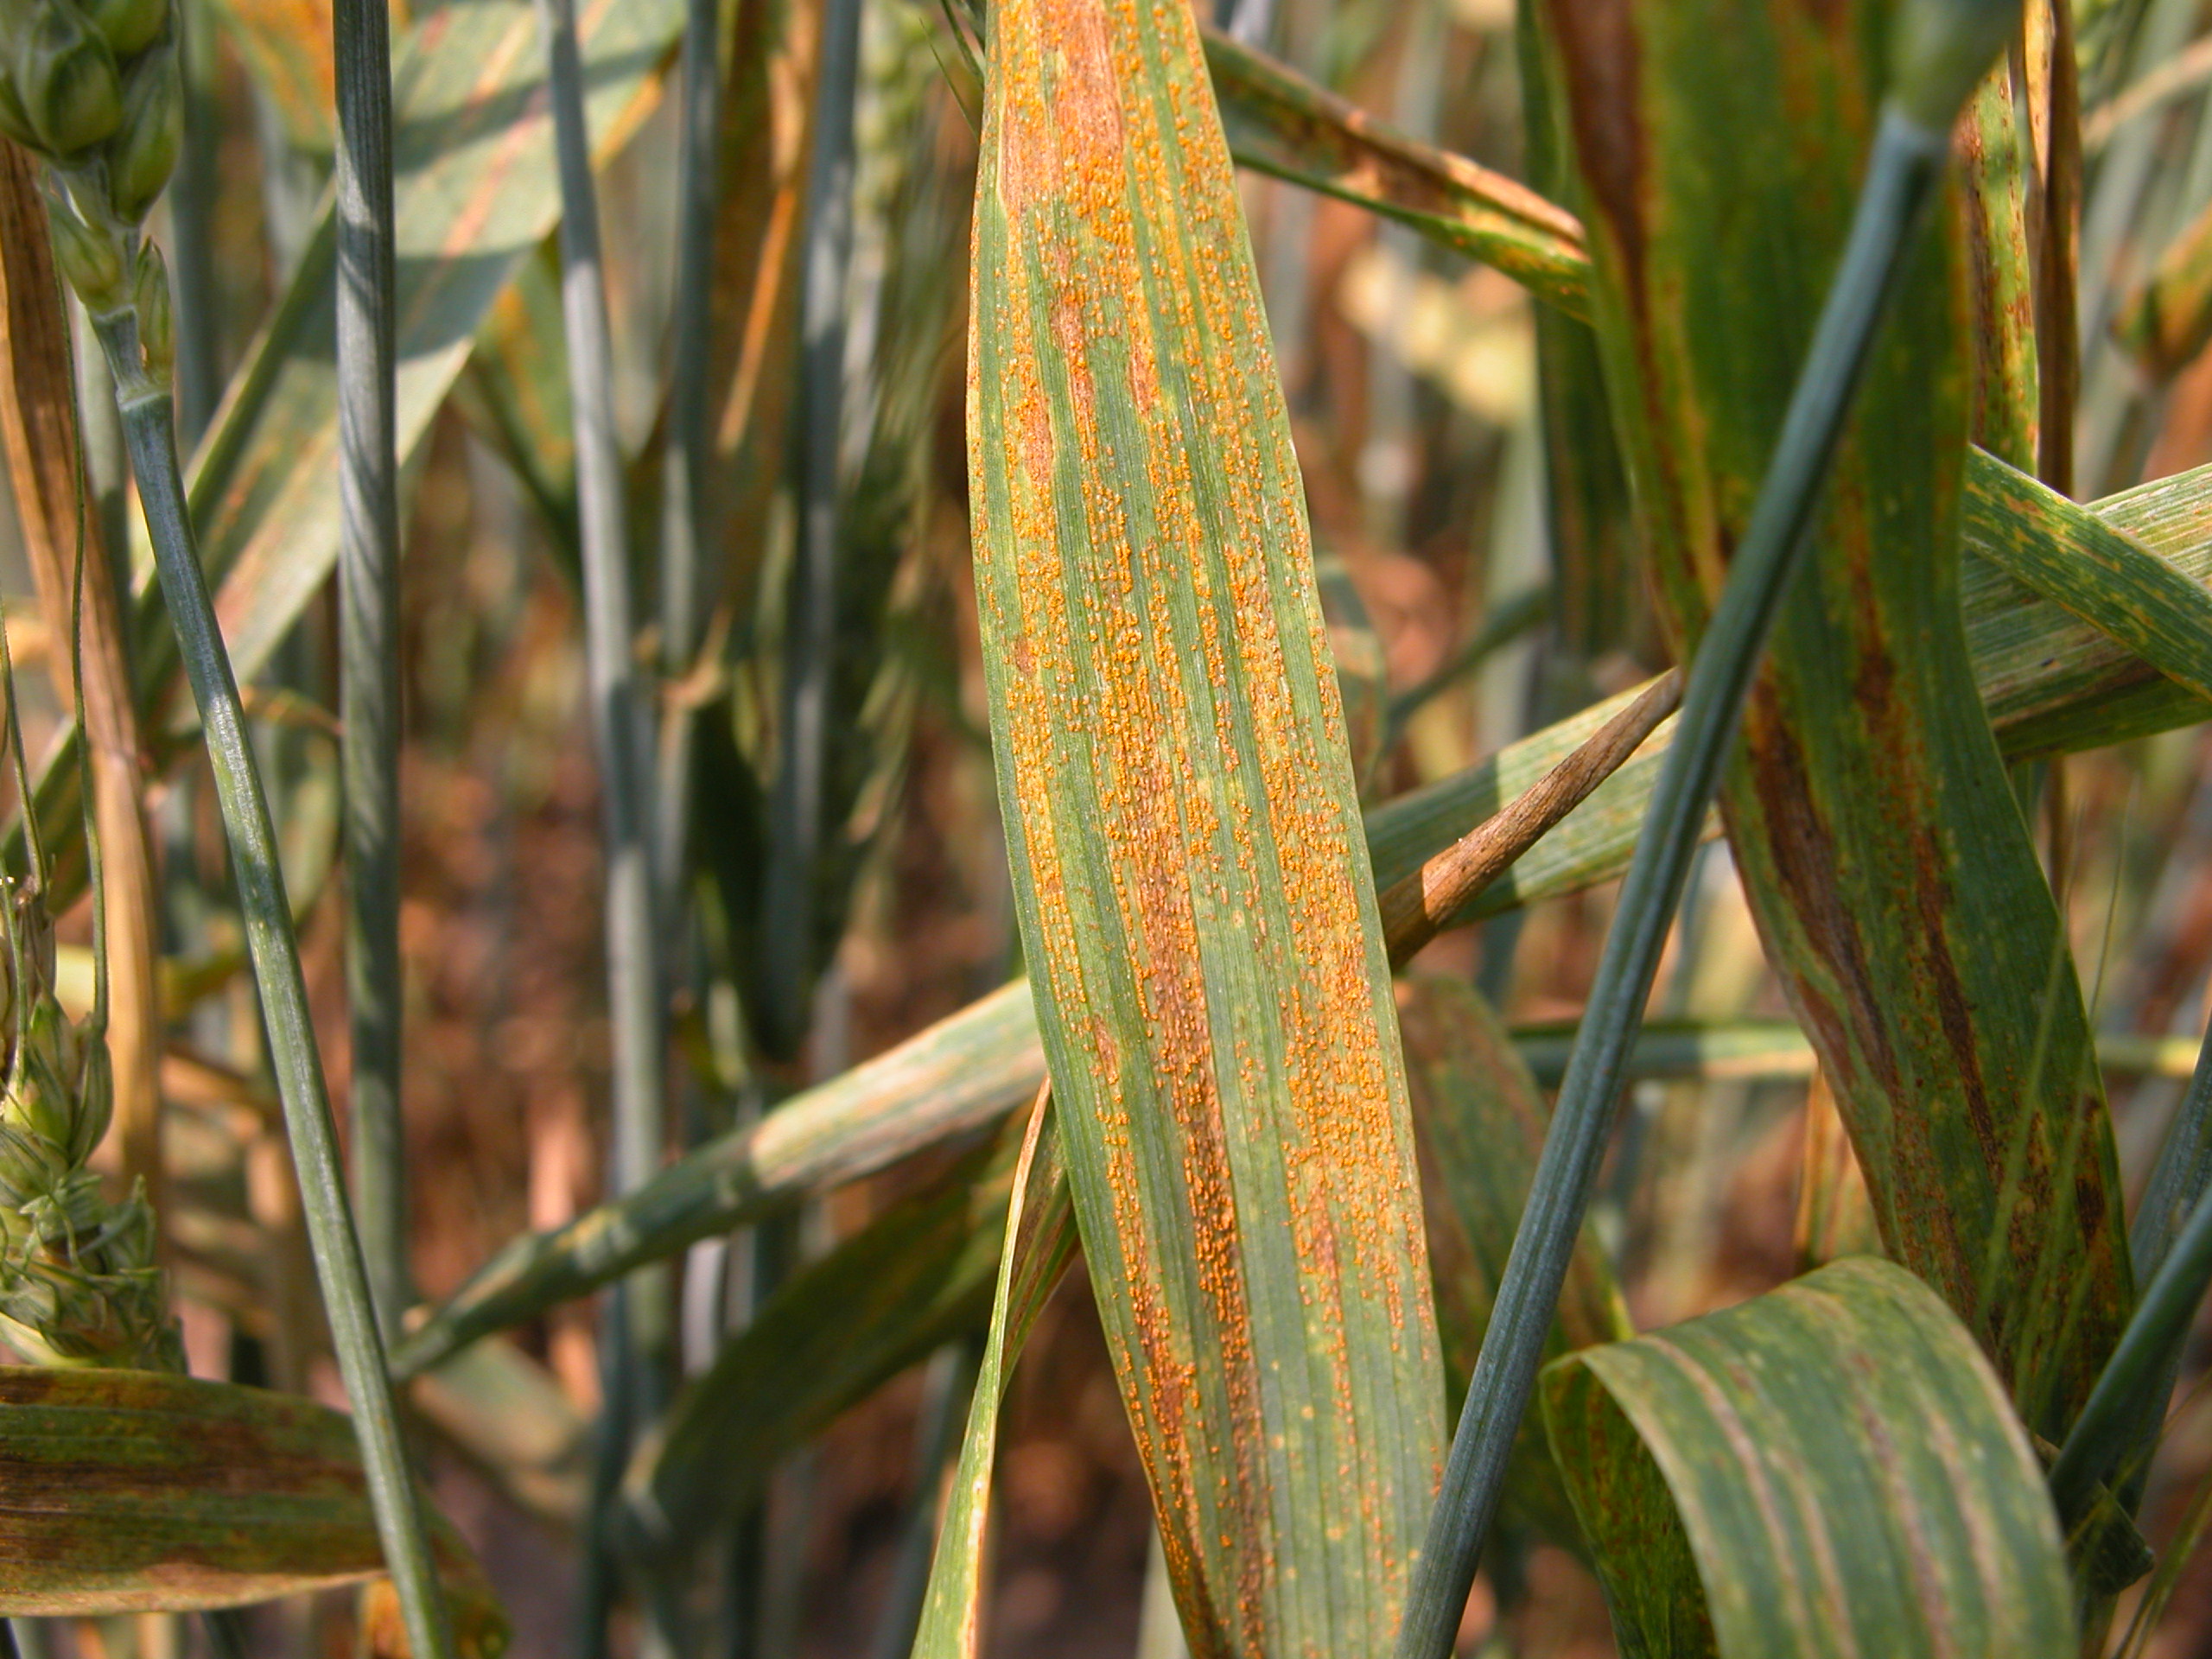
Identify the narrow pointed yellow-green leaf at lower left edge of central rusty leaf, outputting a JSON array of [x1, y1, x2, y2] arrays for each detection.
[[913, 1097, 1075, 1659]]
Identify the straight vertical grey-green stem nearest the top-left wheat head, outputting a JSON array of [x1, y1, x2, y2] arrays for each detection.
[[332, 0, 411, 1340]]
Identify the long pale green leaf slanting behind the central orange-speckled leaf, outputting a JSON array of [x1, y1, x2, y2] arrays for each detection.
[[397, 451, 2212, 1365]]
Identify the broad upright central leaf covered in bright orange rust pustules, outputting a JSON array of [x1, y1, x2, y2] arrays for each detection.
[[969, 0, 1442, 1659]]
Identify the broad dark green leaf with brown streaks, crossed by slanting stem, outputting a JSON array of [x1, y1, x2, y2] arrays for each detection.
[[1551, 0, 2133, 1435]]
